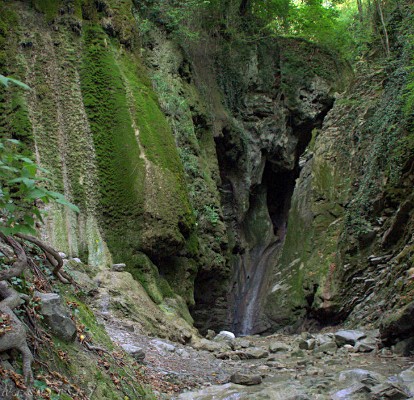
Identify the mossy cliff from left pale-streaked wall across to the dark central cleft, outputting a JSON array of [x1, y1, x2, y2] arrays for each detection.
[[0, 1, 346, 331]]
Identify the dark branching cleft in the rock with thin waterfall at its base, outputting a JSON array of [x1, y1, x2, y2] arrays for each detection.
[[222, 105, 333, 335]]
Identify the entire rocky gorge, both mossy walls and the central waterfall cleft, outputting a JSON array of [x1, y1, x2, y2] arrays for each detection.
[[0, 0, 414, 398]]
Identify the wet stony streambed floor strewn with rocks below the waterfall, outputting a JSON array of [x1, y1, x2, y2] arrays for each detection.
[[105, 320, 414, 400]]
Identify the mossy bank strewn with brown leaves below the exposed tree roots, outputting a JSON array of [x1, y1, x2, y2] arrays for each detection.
[[35, 285, 154, 400]]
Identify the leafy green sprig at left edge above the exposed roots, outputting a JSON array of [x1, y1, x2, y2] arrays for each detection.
[[0, 139, 79, 235]]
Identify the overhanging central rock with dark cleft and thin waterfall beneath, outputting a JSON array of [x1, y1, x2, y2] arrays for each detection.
[[207, 39, 351, 333]]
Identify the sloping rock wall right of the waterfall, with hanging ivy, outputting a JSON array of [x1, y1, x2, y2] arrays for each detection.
[[266, 4, 413, 332]]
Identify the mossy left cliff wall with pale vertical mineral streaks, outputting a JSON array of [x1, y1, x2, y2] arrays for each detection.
[[0, 1, 197, 332]]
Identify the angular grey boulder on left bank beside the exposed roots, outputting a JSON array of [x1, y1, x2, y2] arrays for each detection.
[[35, 292, 76, 342]]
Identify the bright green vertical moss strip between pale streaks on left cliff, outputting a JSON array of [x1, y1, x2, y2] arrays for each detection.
[[81, 24, 145, 262]]
